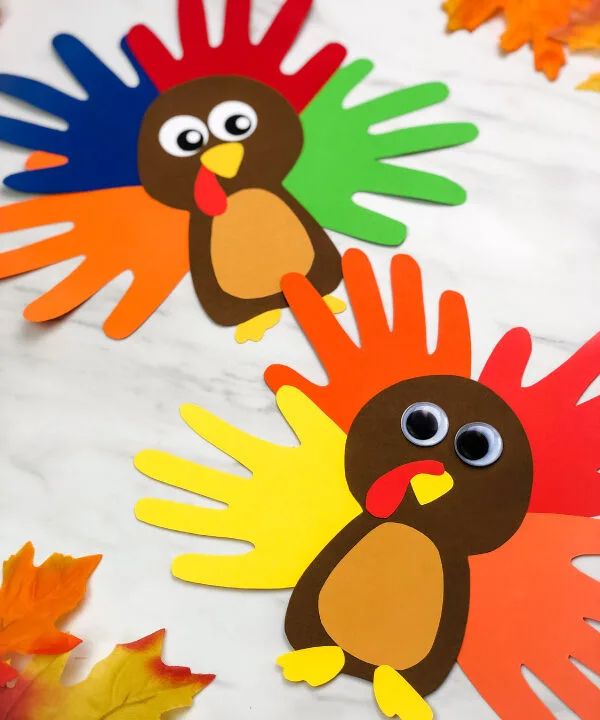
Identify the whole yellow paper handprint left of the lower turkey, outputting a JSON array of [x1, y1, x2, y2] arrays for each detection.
[[135, 387, 360, 590]]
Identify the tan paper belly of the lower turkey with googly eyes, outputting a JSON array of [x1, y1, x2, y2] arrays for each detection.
[[319, 523, 444, 670]]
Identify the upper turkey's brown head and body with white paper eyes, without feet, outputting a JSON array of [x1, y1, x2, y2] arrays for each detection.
[[139, 76, 341, 325]]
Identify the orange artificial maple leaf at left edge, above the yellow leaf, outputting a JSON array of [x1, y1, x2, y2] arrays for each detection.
[[0, 543, 102, 688]]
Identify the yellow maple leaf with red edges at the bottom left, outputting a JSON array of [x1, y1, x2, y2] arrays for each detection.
[[0, 630, 215, 720]]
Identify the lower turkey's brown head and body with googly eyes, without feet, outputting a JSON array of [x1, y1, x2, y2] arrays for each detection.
[[286, 376, 533, 695]]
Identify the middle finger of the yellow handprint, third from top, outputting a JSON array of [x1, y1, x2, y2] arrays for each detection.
[[134, 450, 250, 504]]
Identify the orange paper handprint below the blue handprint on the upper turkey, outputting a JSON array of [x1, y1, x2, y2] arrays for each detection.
[[0, 181, 189, 339]]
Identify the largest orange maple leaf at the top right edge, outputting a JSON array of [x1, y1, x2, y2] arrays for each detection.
[[443, 0, 593, 80]]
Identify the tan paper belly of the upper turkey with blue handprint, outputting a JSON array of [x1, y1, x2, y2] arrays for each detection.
[[210, 189, 315, 299]]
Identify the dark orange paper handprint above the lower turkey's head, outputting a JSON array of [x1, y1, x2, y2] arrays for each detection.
[[265, 250, 471, 431]]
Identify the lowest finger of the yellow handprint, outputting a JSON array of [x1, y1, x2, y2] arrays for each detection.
[[171, 549, 304, 590]]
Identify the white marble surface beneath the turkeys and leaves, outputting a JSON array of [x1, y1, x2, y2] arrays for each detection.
[[0, 0, 600, 720]]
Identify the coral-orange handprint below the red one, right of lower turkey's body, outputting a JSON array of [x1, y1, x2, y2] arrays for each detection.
[[459, 516, 600, 720]]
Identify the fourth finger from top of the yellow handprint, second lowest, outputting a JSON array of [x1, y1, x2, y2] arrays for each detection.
[[135, 498, 247, 540]]
